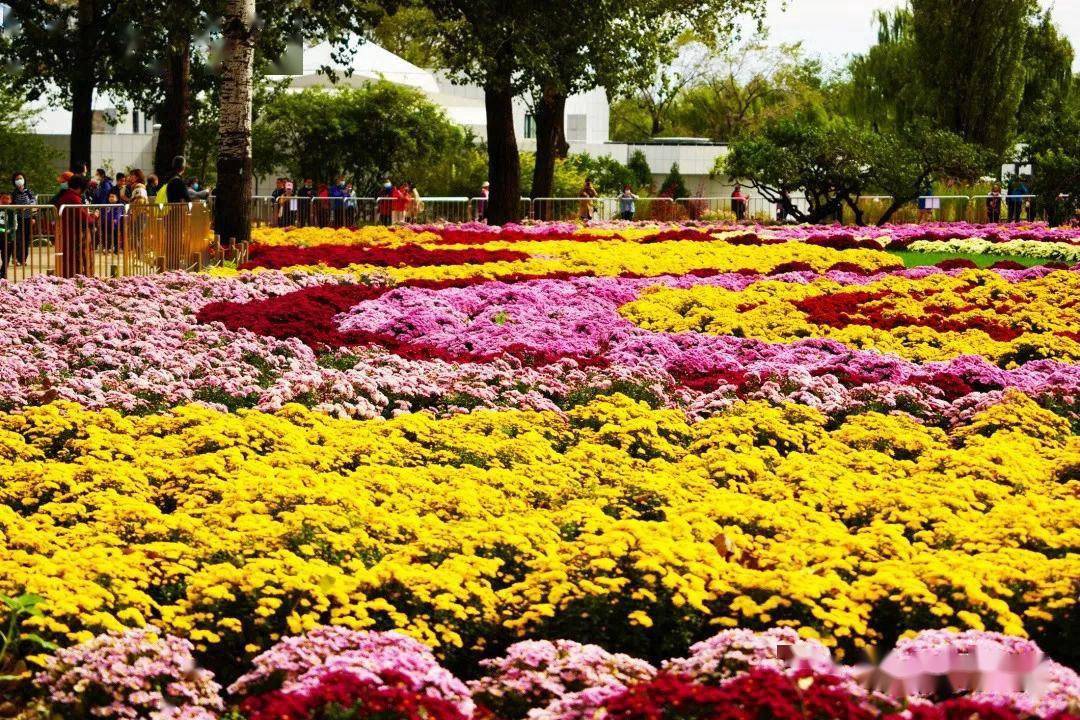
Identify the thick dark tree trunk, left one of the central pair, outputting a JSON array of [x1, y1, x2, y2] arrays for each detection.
[[484, 72, 522, 225]]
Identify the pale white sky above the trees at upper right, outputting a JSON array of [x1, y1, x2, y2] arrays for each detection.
[[766, 0, 1080, 71]]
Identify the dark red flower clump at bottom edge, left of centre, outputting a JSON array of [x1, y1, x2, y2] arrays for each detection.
[[240, 670, 465, 720]]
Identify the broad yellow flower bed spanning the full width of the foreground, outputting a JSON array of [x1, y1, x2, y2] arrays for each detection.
[[0, 393, 1080, 658]]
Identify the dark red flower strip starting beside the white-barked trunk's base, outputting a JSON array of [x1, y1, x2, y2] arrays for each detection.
[[240, 245, 529, 270]]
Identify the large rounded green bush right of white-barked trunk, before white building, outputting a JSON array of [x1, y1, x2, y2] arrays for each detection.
[[254, 81, 486, 195]]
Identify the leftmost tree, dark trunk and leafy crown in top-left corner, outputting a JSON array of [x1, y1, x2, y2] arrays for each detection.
[[0, 0, 127, 165]]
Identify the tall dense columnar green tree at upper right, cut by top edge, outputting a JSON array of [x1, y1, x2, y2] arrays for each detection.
[[912, 0, 1038, 153]]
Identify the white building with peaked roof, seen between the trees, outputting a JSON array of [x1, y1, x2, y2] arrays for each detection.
[[25, 37, 730, 196]]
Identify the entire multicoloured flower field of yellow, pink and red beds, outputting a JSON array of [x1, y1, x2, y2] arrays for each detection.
[[0, 223, 1080, 720]]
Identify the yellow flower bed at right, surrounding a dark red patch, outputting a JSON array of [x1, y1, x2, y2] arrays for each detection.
[[620, 267, 1080, 366]]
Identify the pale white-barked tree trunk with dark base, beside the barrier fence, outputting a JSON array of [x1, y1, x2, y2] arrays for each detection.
[[214, 0, 256, 243]]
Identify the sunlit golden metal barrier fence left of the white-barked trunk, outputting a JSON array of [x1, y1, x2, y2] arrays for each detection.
[[0, 202, 214, 281]]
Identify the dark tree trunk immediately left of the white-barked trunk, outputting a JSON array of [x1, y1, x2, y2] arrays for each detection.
[[153, 29, 191, 178]]
